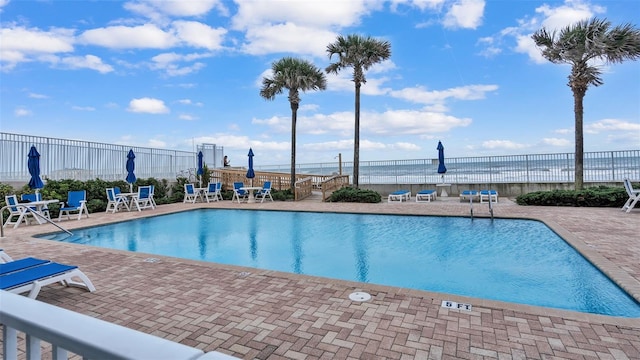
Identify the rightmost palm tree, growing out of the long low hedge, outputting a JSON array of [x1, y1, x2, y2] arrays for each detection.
[[531, 18, 640, 190]]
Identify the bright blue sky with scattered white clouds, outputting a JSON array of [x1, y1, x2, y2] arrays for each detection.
[[0, 0, 640, 165]]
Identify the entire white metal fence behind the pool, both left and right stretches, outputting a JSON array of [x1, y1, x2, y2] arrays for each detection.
[[0, 133, 640, 185]]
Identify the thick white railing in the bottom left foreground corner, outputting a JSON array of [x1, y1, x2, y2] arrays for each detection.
[[0, 290, 237, 360]]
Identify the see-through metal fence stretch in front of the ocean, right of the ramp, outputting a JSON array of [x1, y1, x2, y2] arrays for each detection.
[[256, 150, 640, 185]]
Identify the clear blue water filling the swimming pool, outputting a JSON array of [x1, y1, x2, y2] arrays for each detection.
[[43, 209, 640, 317]]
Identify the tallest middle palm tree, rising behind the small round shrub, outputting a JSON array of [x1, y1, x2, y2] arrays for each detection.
[[326, 35, 391, 188]]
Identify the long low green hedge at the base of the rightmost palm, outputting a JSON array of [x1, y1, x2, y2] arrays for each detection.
[[516, 186, 628, 207]]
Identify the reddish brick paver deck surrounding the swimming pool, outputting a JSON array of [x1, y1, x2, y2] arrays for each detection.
[[0, 198, 640, 360]]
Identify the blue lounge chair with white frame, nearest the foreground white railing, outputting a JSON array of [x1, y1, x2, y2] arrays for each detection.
[[0, 258, 96, 299]]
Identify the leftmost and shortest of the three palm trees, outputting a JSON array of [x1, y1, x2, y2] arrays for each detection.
[[260, 57, 327, 191]]
